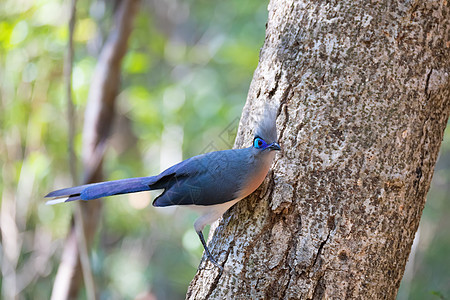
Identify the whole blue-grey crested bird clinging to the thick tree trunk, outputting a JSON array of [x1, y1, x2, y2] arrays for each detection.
[[45, 109, 281, 270]]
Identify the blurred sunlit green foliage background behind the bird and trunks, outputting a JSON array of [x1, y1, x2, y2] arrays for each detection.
[[0, 0, 450, 299]]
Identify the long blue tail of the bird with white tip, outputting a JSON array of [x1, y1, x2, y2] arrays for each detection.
[[45, 177, 154, 205]]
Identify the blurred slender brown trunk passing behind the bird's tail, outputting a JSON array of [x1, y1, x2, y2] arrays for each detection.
[[52, 0, 139, 299]]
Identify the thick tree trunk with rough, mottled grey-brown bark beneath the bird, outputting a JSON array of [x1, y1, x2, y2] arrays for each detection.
[[187, 0, 450, 299]]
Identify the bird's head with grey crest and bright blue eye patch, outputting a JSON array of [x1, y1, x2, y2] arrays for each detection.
[[253, 107, 281, 152]]
